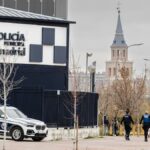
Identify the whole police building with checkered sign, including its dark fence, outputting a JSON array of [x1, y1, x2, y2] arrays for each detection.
[[0, 7, 98, 127]]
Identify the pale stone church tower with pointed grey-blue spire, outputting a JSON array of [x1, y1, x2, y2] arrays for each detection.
[[106, 8, 133, 80]]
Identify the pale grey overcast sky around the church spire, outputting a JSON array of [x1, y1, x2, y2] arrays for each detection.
[[68, 0, 150, 74]]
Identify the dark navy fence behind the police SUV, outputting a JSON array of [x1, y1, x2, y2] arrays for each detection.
[[8, 88, 98, 128]]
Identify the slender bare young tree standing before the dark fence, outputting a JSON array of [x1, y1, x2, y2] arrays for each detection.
[[65, 53, 91, 150]]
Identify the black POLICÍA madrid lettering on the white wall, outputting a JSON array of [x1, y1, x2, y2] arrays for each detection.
[[0, 32, 26, 56]]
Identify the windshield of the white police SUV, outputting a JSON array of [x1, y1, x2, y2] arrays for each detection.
[[6, 109, 27, 118]]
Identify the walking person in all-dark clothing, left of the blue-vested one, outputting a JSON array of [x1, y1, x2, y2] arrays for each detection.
[[121, 109, 134, 140]]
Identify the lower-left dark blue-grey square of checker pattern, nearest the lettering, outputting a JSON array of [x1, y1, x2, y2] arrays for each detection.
[[29, 44, 43, 62]]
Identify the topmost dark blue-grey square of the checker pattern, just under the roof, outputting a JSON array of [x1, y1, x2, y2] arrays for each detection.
[[42, 28, 55, 45]]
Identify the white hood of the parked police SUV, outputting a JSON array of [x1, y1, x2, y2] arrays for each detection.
[[9, 118, 45, 125]]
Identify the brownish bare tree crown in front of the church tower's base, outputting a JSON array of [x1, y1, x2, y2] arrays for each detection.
[[112, 67, 145, 113]]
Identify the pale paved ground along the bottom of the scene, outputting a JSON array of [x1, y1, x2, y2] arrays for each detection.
[[0, 136, 150, 150]]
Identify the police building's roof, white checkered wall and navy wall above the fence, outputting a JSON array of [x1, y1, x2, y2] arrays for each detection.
[[0, 7, 70, 90]]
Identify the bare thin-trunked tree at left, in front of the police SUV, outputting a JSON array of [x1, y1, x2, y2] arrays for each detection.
[[0, 55, 24, 150]]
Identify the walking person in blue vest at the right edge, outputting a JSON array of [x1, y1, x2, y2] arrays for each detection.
[[140, 111, 150, 142]]
